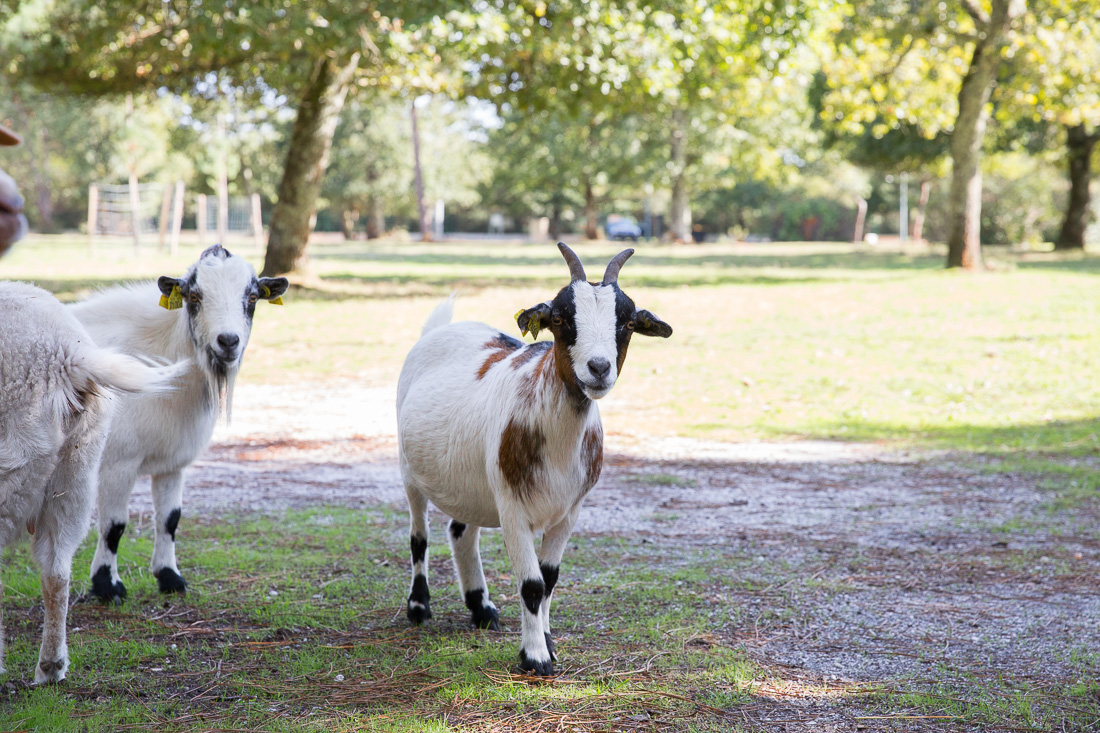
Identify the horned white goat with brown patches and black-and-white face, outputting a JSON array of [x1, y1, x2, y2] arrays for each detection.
[[397, 242, 672, 675]]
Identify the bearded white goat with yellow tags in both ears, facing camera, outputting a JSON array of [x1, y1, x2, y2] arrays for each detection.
[[72, 245, 288, 603]]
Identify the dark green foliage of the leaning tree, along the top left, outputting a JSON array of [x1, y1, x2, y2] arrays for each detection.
[[0, 0, 447, 96]]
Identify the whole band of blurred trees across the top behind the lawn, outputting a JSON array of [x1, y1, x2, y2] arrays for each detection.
[[0, 0, 1100, 268]]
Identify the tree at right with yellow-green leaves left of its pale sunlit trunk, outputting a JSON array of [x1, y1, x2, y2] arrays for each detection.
[[822, 0, 1034, 269]]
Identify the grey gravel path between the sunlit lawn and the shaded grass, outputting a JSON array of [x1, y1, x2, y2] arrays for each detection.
[[132, 385, 1100, 726]]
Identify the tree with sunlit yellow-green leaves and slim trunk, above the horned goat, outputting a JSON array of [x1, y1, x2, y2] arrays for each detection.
[[455, 0, 817, 244]]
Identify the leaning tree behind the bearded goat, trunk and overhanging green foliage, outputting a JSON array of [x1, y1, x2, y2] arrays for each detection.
[[0, 0, 448, 275]]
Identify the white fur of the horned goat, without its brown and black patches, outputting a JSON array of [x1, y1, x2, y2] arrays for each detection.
[[397, 296, 614, 670]]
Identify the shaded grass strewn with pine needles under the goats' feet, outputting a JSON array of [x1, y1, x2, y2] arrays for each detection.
[[0, 507, 766, 731]]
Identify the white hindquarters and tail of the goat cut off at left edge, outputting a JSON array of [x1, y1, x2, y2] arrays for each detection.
[[0, 283, 188, 682]]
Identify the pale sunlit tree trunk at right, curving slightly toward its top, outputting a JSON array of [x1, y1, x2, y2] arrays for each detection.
[[947, 0, 1026, 270]]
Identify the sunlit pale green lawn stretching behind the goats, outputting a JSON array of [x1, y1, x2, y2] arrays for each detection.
[[8, 238, 1100, 456]]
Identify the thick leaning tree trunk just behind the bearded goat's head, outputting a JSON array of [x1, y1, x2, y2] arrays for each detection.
[[263, 54, 360, 277]]
